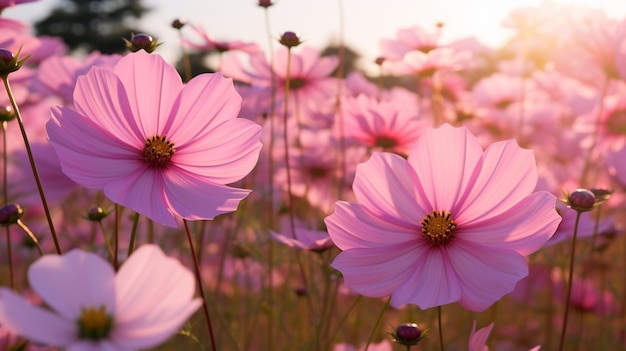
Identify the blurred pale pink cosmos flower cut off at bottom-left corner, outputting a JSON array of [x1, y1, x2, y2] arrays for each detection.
[[0, 245, 202, 350]]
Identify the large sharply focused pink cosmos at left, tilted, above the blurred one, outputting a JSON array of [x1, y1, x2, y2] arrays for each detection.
[[47, 50, 261, 227]]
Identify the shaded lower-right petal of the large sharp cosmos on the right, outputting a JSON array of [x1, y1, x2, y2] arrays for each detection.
[[446, 239, 528, 312]]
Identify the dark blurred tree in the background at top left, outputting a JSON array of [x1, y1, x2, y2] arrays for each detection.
[[35, 0, 149, 54]]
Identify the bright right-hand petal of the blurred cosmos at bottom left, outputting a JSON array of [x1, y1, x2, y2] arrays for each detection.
[[111, 245, 201, 348]]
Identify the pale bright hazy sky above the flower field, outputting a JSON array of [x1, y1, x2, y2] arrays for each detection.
[[3, 0, 626, 69]]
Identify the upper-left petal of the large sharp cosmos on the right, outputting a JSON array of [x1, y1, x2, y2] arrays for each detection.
[[352, 152, 431, 225]]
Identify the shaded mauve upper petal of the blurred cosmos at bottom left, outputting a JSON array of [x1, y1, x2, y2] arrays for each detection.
[[28, 249, 115, 320]]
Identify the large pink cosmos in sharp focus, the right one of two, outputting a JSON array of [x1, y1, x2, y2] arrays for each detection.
[[325, 124, 560, 311]]
